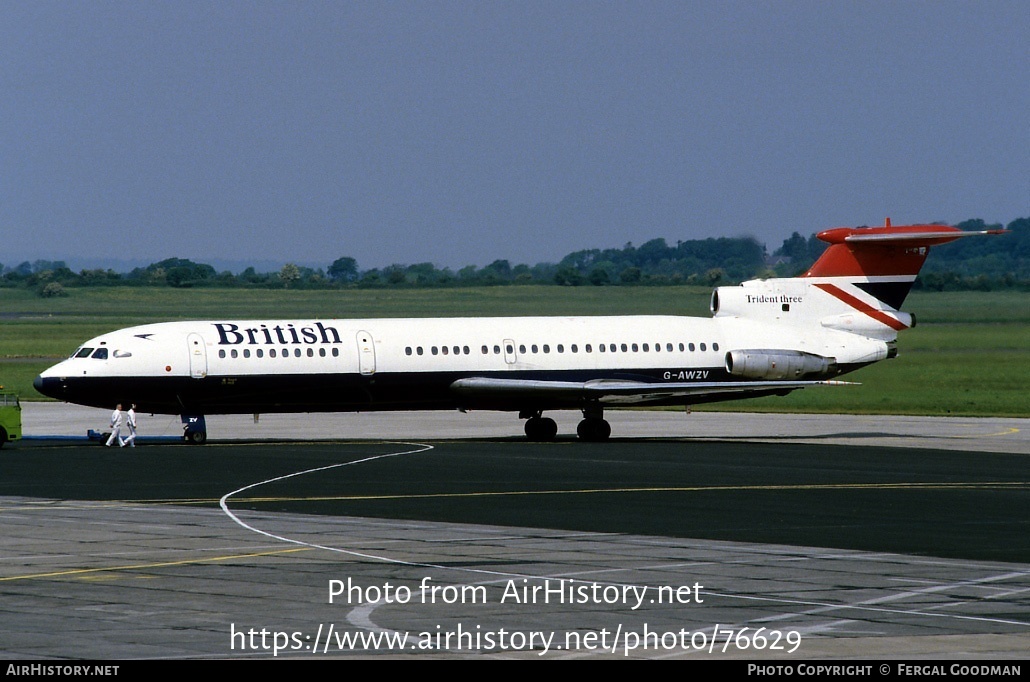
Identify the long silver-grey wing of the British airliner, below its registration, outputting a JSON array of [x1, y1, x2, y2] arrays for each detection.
[[451, 377, 850, 405]]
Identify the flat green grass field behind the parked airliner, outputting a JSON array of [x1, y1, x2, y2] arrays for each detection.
[[0, 286, 1030, 417]]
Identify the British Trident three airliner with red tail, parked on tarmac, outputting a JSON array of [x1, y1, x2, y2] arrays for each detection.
[[33, 218, 1005, 444]]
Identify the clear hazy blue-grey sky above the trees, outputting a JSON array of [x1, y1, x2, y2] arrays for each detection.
[[0, 0, 1030, 269]]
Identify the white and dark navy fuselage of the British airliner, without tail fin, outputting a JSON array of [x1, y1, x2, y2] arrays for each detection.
[[37, 315, 886, 414]]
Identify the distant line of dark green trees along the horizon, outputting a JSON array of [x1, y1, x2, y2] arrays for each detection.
[[6, 218, 1030, 297]]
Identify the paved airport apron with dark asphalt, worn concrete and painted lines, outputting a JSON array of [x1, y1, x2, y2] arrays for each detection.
[[0, 404, 1030, 660]]
